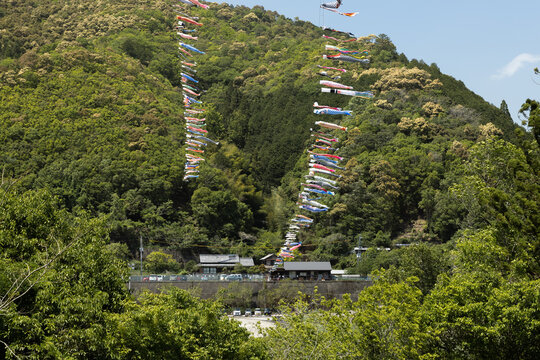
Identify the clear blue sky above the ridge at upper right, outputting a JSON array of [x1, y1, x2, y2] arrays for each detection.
[[218, 0, 540, 121]]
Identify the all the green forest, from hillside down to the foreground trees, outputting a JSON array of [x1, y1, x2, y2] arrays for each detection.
[[0, 0, 540, 359]]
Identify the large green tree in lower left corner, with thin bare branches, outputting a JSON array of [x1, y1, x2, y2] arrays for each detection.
[[0, 188, 127, 359]]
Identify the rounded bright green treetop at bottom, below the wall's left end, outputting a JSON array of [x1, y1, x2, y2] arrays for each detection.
[[105, 288, 264, 360]]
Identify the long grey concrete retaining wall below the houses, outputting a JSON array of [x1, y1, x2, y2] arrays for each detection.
[[128, 281, 371, 303]]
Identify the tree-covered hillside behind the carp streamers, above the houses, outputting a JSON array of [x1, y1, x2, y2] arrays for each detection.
[[0, 0, 528, 266]]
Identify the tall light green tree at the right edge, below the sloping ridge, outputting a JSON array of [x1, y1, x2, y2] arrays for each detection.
[[451, 139, 540, 276]]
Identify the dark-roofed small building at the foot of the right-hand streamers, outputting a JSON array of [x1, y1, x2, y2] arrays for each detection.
[[272, 261, 332, 280]]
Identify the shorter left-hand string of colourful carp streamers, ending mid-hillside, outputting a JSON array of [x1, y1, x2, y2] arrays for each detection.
[[175, 0, 219, 181]]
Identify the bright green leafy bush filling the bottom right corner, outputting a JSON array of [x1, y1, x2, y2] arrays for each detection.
[[422, 271, 540, 359]]
